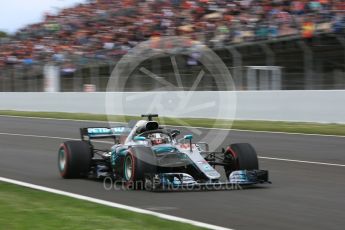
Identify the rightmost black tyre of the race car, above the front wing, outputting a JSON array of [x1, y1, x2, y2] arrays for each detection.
[[224, 143, 259, 178]]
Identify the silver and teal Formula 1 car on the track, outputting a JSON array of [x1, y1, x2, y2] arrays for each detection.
[[58, 114, 270, 191]]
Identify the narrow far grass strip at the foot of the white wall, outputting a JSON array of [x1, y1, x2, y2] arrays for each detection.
[[0, 110, 345, 136]]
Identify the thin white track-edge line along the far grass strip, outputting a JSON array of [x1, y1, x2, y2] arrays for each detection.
[[0, 115, 345, 138]]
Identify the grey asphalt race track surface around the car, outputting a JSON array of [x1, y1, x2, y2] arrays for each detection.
[[0, 116, 345, 230]]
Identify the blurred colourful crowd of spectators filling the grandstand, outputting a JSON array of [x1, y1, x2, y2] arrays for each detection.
[[0, 0, 345, 68]]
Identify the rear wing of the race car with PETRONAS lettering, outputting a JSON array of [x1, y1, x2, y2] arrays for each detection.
[[80, 126, 130, 141]]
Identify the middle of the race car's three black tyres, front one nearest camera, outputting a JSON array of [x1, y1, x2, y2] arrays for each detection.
[[123, 146, 157, 189]]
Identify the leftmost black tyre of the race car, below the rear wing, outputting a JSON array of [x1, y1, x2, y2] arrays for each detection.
[[58, 141, 92, 179]]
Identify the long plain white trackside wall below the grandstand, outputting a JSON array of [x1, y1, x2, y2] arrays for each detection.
[[0, 90, 345, 123]]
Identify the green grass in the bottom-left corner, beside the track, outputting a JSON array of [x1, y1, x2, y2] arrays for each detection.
[[0, 182, 201, 230]]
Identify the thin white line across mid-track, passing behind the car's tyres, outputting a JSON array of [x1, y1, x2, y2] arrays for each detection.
[[0, 133, 345, 167]]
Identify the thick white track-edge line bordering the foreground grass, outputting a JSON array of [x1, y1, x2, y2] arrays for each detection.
[[0, 177, 231, 230]]
